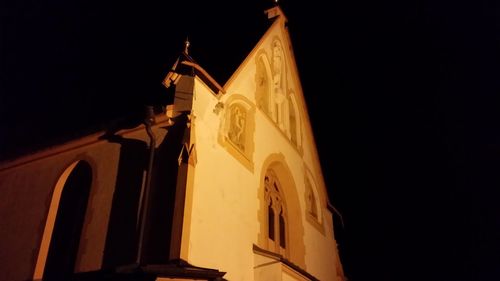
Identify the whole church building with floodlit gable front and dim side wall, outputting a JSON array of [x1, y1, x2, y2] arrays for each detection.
[[0, 7, 345, 281]]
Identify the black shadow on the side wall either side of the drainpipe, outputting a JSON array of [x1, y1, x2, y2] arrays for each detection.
[[103, 112, 187, 269]]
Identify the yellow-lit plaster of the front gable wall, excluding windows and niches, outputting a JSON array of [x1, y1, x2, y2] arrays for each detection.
[[188, 17, 337, 280]]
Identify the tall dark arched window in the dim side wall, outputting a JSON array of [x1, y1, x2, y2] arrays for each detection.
[[33, 160, 93, 280]]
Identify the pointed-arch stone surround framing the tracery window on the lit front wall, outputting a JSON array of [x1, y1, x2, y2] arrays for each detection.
[[258, 154, 306, 268]]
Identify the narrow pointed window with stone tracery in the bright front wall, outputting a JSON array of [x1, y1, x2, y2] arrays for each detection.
[[264, 167, 287, 256]]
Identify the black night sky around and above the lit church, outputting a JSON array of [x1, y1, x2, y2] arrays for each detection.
[[0, 0, 500, 281]]
